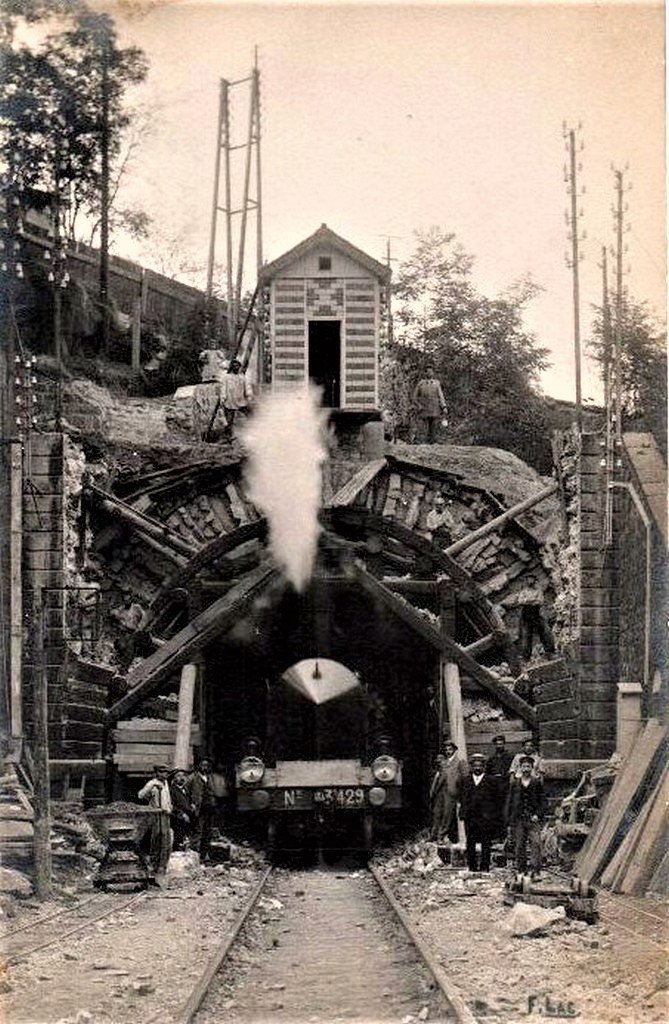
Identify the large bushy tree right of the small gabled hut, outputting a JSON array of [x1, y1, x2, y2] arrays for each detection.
[[381, 227, 549, 470]]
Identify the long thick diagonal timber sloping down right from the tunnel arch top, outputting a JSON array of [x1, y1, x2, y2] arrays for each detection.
[[353, 564, 537, 726]]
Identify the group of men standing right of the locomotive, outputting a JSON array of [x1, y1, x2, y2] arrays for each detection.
[[430, 734, 545, 877]]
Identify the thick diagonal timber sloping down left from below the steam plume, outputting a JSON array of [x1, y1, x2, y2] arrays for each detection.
[[109, 564, 279, 723]]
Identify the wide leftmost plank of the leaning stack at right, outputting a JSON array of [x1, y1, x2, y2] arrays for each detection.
[[575, 719, 667, 882]]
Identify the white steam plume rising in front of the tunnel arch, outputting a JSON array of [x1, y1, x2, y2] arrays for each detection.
[[242, 387, 326, 590]]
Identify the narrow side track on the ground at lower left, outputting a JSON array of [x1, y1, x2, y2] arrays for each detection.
[[2, 892, 144, 966]]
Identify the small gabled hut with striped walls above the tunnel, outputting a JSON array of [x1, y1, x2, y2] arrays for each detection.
[[260, 224, 390, 414]]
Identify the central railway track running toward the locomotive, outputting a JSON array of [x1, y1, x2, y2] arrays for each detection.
[[165, 867, 477, 1024]]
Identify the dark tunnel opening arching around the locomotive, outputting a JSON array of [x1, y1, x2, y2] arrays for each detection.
[[202, 577, 438, 826]]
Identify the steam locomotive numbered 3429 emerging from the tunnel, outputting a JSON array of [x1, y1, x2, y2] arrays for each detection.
[[236, 658, 402, 853]]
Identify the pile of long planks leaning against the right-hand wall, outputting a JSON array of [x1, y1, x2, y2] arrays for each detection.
[[575, 719, 669, 896]]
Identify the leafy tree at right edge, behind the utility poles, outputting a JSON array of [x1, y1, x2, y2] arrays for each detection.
[[588, 297, 667, 454]]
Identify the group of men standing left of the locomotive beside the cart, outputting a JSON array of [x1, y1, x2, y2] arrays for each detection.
[[138, 758, 225, 876]]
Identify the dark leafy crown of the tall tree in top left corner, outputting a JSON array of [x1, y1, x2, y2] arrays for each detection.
[[0, 0, 148, 237]]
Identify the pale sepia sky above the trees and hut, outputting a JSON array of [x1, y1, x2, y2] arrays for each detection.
[[93, 0, 666, 400]]
